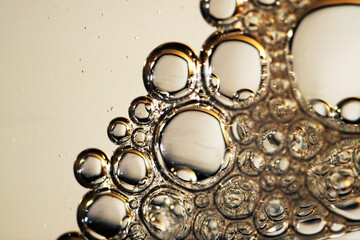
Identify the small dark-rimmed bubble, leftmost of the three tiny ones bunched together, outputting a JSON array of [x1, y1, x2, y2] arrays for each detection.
[[107, 117, 131, 144]]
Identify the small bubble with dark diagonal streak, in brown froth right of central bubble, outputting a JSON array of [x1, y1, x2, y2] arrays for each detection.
[[258, 125, 285, 154]]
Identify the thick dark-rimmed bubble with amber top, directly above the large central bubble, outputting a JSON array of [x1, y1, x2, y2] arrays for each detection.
[[143, 42, 198, 101]]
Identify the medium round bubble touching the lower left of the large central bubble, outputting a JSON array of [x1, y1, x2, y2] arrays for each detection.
[[111, 149, 152, 192]]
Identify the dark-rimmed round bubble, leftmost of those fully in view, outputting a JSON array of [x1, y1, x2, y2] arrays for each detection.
[[74, 148, 109, 188]]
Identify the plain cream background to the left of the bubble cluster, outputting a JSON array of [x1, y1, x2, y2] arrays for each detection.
[[0, 0, 355, 239]]
